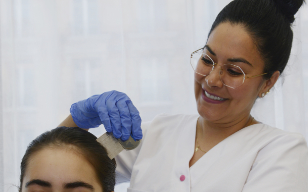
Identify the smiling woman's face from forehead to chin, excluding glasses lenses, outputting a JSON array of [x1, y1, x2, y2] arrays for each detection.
[[195, 23, 265, 123]]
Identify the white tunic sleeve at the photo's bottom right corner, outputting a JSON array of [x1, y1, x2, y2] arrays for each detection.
[[243, 133, 308, 192]]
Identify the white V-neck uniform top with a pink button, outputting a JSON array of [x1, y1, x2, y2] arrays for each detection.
[[116, 114, 308, 192]]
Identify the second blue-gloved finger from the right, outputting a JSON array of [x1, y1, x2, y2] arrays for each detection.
[[116, 99, 132, 141]]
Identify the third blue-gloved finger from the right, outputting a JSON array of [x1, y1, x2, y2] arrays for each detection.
[[106, 96, 122, 139]]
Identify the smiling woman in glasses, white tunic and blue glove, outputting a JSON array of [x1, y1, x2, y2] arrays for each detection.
[[62, 0, 308, 192]]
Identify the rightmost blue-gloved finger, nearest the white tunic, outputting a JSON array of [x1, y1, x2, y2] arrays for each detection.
[[126, 100, 142, 140]]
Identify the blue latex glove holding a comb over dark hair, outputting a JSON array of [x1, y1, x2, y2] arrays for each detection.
[[70, 91, 142, 141]]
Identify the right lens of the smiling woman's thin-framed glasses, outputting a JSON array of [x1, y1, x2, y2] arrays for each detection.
[[220, 64, 245, 89]]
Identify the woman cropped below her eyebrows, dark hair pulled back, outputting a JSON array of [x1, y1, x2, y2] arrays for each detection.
[[19, 127, 115, 192]]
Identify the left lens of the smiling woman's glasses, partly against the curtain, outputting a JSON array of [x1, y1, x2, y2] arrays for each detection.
[[190, 49, 214, 76]]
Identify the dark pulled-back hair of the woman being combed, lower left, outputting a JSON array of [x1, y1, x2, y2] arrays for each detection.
[[19, 127, 116, 192]]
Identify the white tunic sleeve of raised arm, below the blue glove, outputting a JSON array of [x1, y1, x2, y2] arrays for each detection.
[[115, 122, 150, 184]]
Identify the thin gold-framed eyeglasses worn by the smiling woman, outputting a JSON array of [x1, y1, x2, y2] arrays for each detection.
[[190, 48, 266, 89]]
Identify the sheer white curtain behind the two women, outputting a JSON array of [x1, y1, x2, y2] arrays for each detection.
[[0, 0, 308, 192]]
